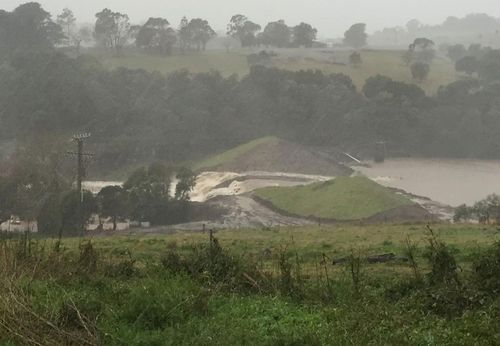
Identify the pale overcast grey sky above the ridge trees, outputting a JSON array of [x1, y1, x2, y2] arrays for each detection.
[[0, 0, 500, 37]]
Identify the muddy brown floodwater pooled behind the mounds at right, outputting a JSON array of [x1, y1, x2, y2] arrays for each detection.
[[356, 158, 500, 206]]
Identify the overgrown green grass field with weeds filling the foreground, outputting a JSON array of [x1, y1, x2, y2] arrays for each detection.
[[0, 225, 500, 345]]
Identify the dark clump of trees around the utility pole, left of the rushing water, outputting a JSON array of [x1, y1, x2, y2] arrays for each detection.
[[0, 147, 196, 236]]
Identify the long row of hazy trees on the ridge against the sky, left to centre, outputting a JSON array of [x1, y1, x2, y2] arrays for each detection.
[[0, 2, 324, 55]]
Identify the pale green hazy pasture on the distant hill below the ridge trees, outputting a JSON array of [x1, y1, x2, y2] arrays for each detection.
[[103, 49, 456, 93]]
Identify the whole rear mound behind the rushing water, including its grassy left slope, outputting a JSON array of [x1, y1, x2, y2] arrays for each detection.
[[193, 137, 352, 176]]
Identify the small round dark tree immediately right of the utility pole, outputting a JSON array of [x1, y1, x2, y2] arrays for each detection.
[[97, 186, 129, 231]]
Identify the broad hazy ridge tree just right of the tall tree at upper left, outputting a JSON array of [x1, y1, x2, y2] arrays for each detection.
[[135, 18, 177, 55]]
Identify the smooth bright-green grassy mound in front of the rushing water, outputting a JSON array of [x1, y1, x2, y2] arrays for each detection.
[[256, 177, 414, 221]]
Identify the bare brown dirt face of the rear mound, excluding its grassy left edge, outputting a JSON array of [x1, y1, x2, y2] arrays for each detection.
[[207, 140, 353, 177]]
